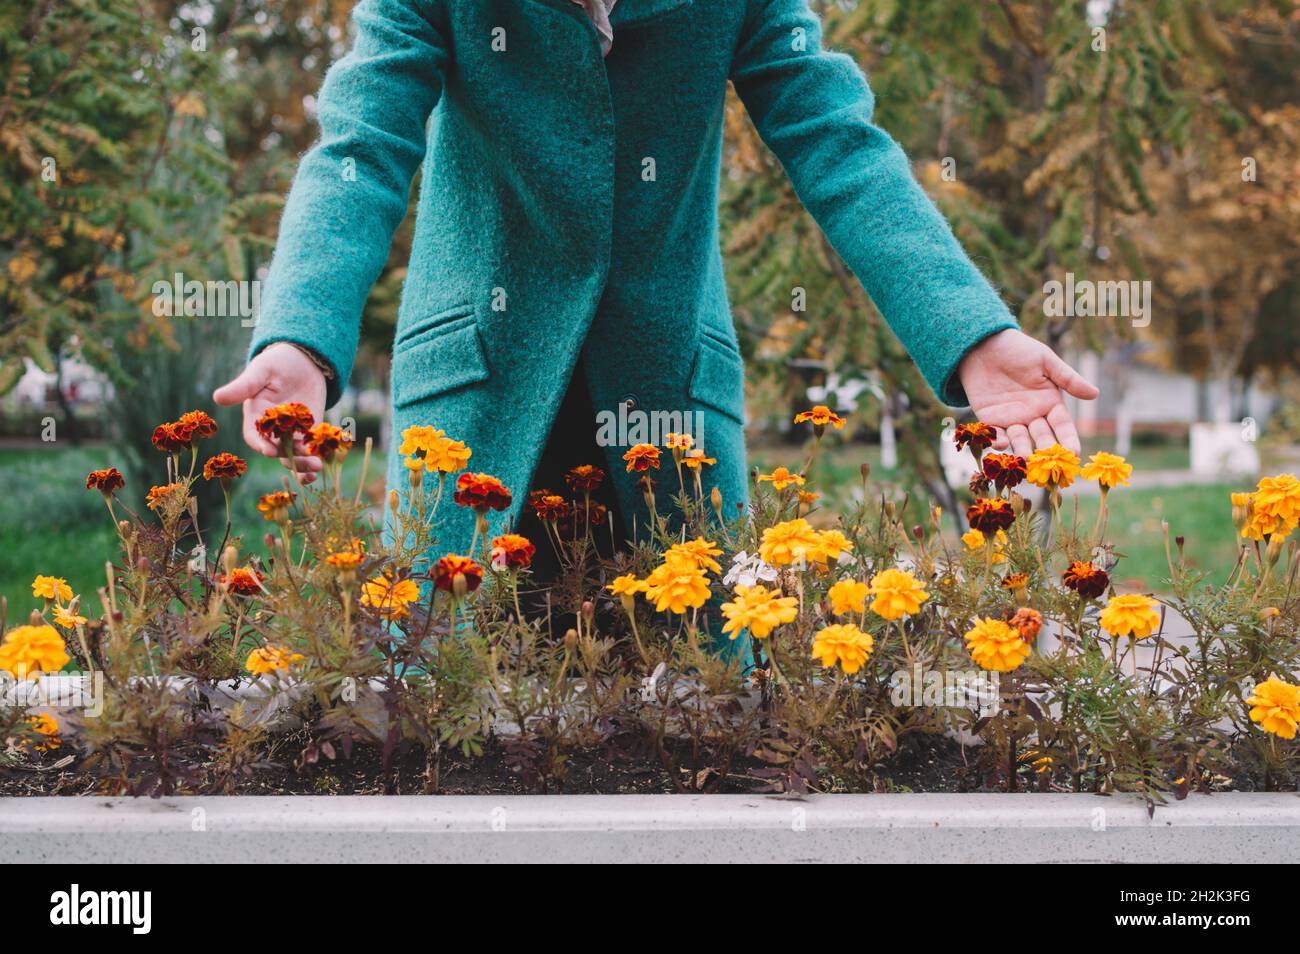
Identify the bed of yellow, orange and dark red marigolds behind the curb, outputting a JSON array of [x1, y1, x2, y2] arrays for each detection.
[[0, 406, 1300, 806]]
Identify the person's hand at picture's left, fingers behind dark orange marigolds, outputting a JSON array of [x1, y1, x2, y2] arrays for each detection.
[[212, 342, 325, 483]]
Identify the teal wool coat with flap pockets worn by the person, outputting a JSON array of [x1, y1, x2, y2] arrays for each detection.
[[252, 0, 1014, 561]]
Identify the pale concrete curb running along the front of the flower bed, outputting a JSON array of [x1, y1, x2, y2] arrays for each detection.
[[0, 793, 1300, 864]]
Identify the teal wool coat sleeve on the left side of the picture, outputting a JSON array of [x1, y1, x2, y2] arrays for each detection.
[[250, 0, 447, 404]]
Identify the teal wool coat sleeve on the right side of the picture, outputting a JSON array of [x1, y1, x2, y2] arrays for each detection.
[[732, 0, 1017, 406]]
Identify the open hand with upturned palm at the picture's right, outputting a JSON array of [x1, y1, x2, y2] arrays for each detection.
[[957, 330, 1099, 458]]
